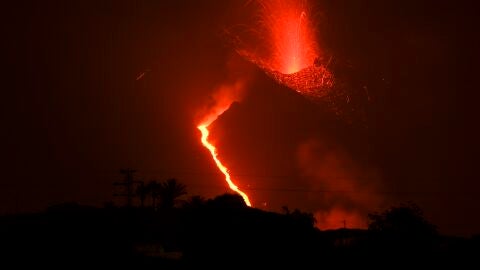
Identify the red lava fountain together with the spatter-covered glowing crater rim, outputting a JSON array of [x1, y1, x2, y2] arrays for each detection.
[[232, 0, 334, 100]]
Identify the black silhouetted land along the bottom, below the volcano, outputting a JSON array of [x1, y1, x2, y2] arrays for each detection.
[[0, 199, 480, 269]]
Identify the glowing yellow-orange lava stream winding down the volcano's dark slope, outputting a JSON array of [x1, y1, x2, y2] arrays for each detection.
[[197, 82, 252, 206]]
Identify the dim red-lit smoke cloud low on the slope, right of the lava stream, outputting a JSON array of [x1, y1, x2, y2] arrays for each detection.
[[297, 139, 383, 229]]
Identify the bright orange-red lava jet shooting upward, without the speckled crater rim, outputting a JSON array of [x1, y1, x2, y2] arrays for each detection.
[[258, 0, 320, 74]]
